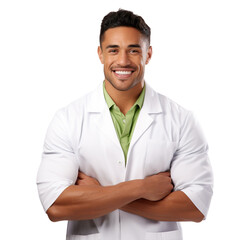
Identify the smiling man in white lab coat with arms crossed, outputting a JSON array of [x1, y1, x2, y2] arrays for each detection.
[[37, 10, 212, 240]]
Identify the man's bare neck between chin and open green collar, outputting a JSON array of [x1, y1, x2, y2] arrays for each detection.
[[105, 80, 144, 115]]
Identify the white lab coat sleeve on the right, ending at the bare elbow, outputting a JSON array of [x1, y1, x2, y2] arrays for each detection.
[[171, 112, 213, 218]]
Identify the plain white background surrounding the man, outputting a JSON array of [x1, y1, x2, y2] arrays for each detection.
[[0, 0, 240, 240]]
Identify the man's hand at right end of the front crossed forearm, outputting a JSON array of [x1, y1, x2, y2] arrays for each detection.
[[142, 172, 173, 201]]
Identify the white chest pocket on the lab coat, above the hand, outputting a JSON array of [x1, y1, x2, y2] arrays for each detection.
[[144, 140, 176, 176]]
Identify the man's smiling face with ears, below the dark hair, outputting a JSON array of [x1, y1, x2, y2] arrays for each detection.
[[98, 27, 152, 91]]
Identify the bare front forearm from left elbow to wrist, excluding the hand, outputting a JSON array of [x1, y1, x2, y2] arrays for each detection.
[[47, 180, 142, 221]]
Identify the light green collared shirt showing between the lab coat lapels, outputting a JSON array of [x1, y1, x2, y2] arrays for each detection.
[[103, 83, 145, 164]]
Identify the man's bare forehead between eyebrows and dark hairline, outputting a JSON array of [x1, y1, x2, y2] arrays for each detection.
[[102, 27, 146, 46]]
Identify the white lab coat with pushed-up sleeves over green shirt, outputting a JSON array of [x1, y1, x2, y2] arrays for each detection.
[[37, 81, 213, 240]]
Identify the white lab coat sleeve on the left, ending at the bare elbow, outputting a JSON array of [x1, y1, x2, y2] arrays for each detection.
[[37, 109, 78, 211]]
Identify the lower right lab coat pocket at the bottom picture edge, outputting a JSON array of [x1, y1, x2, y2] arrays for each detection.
[[145, 230, 182, 240]]
